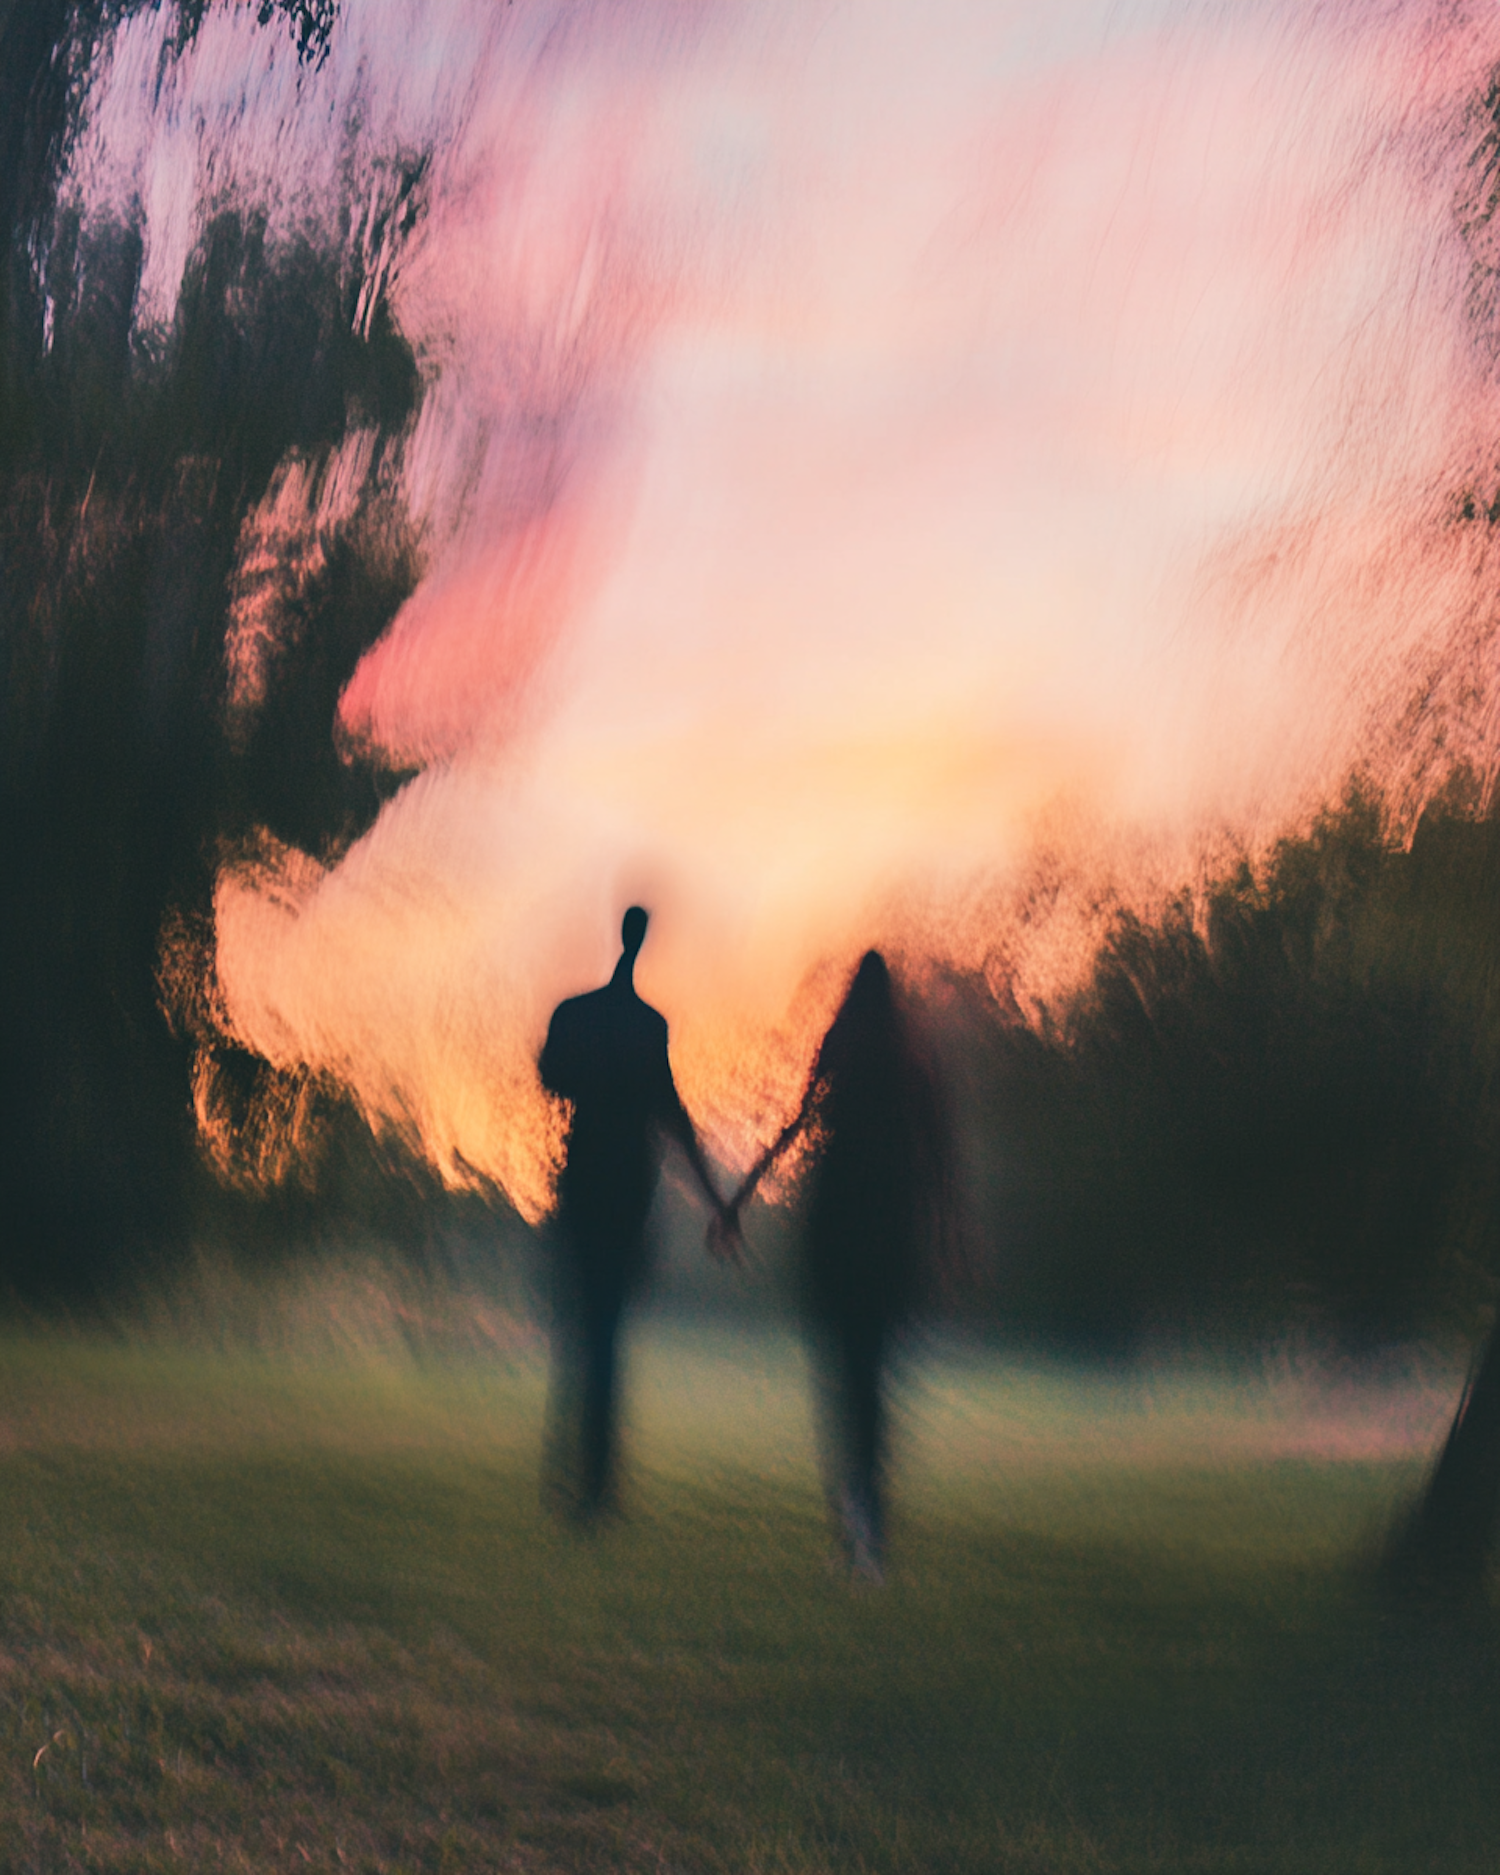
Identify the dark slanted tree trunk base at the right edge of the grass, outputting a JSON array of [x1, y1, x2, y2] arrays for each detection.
[[1391, 1322, 1500, 1596]]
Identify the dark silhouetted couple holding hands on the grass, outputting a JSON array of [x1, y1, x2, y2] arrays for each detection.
[[538, 906, 938, 1581]]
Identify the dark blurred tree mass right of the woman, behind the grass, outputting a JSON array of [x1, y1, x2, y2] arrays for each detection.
[[966, 776, 1500, 1348]]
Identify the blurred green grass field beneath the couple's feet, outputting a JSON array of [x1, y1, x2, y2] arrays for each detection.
[[0, 1324, 1500, 1875]]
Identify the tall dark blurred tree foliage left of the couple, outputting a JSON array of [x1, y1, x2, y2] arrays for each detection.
[[0, 0, 513, 1299]]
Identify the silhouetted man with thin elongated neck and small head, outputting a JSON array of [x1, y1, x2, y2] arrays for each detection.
[[538, 906, 735, 1517]]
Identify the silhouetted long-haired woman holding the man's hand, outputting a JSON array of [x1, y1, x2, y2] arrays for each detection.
[[729, 951, 941, 1581]]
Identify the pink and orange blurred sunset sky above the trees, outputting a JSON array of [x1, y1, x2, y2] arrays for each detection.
[[64, 0, 1500, 1215]]
